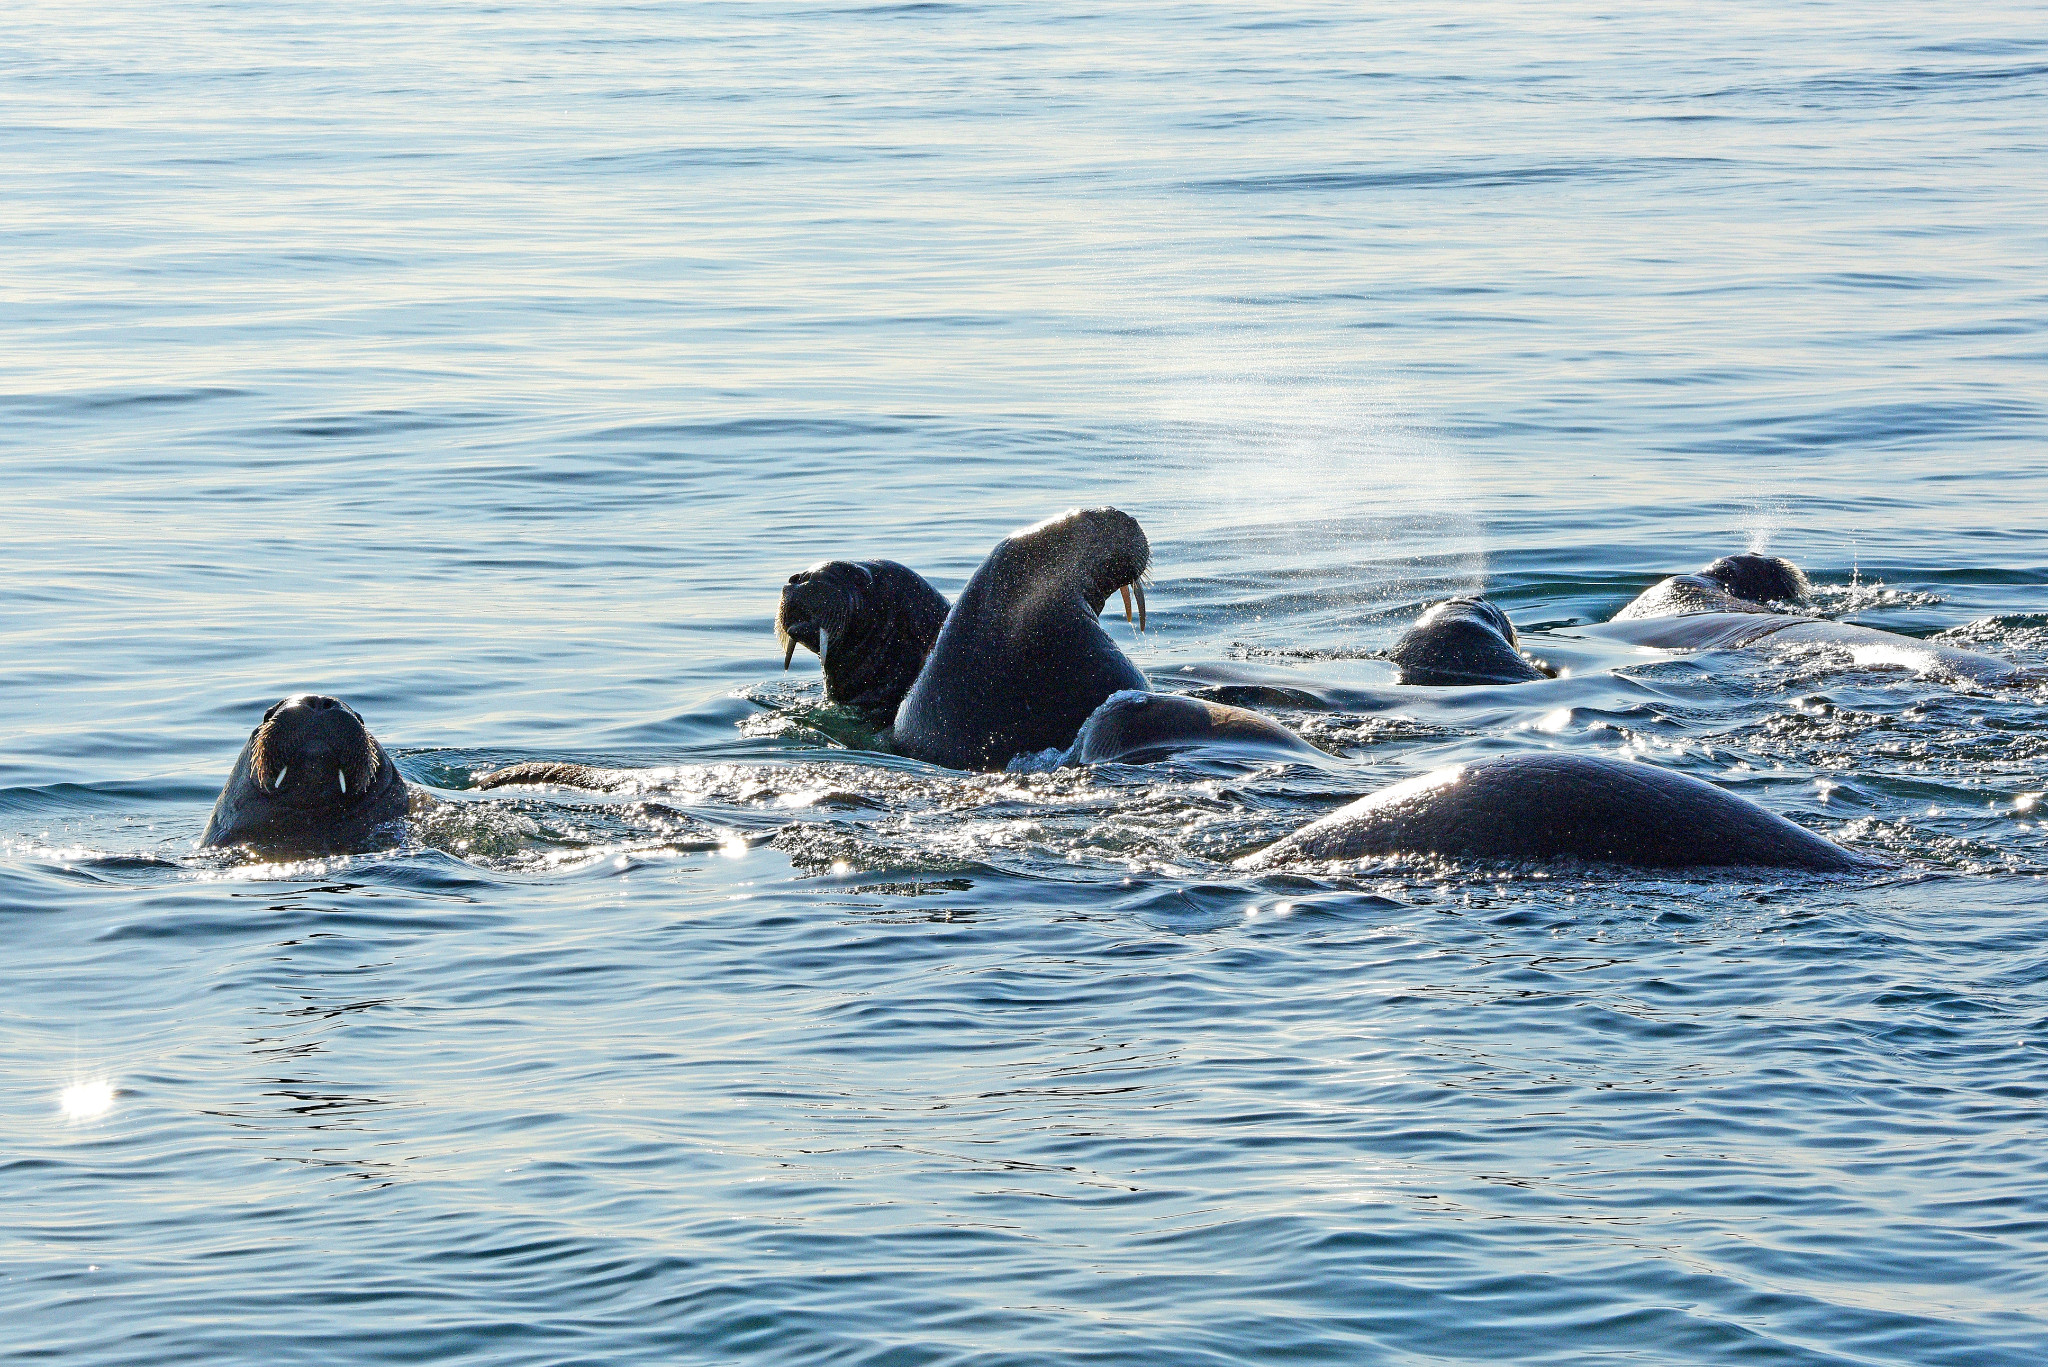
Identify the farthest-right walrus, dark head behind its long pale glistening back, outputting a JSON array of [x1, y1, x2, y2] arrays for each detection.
[[1587, 555, 2036, 682]]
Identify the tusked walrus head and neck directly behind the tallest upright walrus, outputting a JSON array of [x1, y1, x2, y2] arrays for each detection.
[[774, 560, 948, 730]]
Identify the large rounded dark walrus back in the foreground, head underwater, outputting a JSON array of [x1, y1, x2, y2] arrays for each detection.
[[1235, 754, 1884, 873]]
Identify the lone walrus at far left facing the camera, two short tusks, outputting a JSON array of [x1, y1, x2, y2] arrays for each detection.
[[199, 693, 412, 855]]
